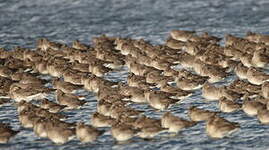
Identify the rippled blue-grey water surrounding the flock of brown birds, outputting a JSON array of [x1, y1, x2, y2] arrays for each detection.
[[0, 0, 269, 150]]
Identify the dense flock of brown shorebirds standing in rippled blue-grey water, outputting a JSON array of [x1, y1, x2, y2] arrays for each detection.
[[0, 30, 269, 144]]
